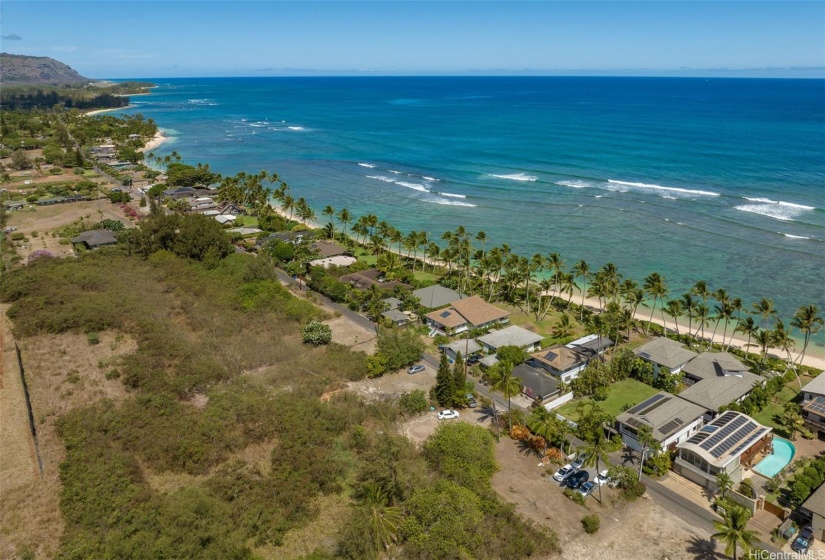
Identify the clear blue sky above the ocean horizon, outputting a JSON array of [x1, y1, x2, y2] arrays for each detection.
[[0, 0, 825, 78]]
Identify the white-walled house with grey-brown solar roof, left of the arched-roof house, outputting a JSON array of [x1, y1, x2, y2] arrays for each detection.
[[616, 391, 705, 451]]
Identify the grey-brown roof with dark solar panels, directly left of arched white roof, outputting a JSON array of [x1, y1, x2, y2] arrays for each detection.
[[616, 391, 705, 442]]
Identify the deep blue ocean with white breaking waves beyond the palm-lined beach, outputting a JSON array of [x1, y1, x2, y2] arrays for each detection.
[[120, 77, 825, 354]]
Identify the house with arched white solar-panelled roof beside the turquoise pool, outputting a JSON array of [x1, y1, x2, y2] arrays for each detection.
[[673, 410, 773, 491]]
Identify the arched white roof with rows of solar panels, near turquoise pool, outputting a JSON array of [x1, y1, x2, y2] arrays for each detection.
[[678, 410, 771, 467]]
